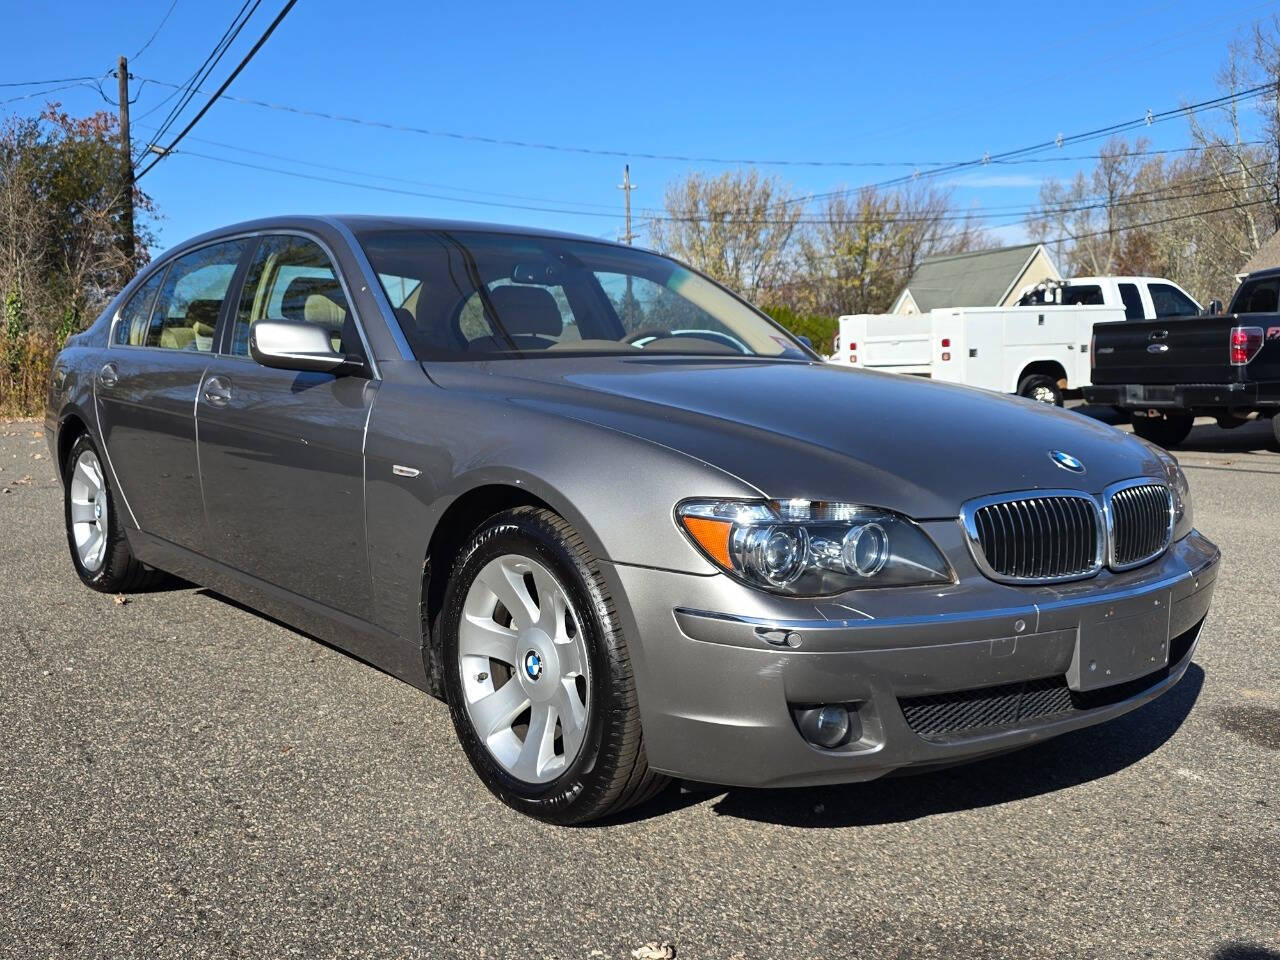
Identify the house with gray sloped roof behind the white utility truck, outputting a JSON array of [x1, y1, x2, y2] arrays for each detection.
[[890, 243, 1062, 315]]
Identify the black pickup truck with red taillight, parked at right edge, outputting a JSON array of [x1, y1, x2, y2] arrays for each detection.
[[1084, 269, 1280, 447]]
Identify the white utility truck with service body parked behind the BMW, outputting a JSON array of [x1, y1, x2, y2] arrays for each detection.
[[831, 276, 1201, 406]]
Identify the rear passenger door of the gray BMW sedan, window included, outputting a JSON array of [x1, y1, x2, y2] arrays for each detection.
[[95, 239, 248, 549]]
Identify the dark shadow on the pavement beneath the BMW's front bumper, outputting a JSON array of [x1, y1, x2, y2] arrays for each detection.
[[686, 663, 1204, 828]]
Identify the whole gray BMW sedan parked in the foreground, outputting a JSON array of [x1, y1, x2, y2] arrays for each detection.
[[45, 216, 1219, 823]]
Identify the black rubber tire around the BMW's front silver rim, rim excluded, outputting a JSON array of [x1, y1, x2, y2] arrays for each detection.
[[440, 507, 669, 824]]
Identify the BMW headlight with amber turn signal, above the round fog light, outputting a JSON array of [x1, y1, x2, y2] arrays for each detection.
[[676, 500, 954, 596]]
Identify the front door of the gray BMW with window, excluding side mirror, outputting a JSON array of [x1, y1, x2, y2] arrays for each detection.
[[196, 234, 378, 618]]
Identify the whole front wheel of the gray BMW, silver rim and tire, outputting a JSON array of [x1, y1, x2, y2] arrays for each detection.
[[442, 507, 667, 824]]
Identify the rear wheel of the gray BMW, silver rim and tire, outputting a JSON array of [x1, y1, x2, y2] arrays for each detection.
[[63, 434, 165, 594]]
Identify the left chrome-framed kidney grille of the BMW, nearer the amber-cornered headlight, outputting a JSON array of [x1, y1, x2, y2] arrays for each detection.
[[960, 481, 1105, 584]]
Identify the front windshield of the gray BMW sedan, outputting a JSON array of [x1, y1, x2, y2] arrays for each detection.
[[350, 229, 810, 360]]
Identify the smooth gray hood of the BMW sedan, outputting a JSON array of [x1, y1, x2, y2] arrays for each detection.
[[428, 357, 1162, 518]]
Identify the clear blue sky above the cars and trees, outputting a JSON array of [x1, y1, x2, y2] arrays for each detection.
[[0, 0, 1275, 252]]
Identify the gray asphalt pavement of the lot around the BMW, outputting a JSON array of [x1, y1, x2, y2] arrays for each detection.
[[0, 422, 1280, 960]]
